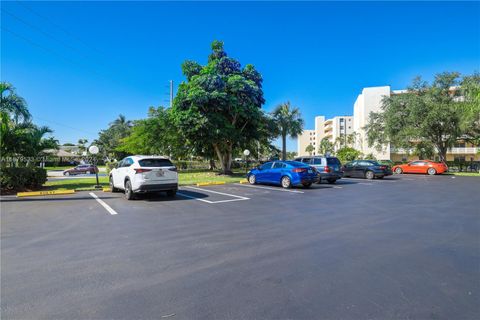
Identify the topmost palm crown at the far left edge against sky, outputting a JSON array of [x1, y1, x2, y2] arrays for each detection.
[[0, 82, 31, 123]]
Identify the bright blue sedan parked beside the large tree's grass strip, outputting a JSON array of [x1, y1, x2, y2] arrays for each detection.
[[247, 161, 318, 188]]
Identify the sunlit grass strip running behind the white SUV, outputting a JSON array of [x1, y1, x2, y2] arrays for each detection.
[[43, 171, 245, 190]]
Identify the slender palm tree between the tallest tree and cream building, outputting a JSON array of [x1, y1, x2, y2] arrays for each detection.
[[272, 101, 304, 160]]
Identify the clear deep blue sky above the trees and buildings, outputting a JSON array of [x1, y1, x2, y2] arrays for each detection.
[[1, 1, 480, 151]]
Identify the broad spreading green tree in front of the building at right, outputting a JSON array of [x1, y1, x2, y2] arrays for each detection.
[[366, 72, 479, 161]]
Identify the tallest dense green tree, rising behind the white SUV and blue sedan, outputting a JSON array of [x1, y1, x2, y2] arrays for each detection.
[[172, 41, 265, 173]]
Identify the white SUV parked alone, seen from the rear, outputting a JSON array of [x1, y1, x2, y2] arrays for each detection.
[[110, 156, 178, 200]]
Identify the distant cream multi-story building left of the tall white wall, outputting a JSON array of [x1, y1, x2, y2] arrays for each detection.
[[297, 116, 353, 156]]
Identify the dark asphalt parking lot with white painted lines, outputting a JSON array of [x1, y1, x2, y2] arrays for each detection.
[[1, 175, 480, 319]]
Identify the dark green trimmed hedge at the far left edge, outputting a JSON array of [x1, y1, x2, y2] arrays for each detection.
[[0, 167, 47, 191]]
